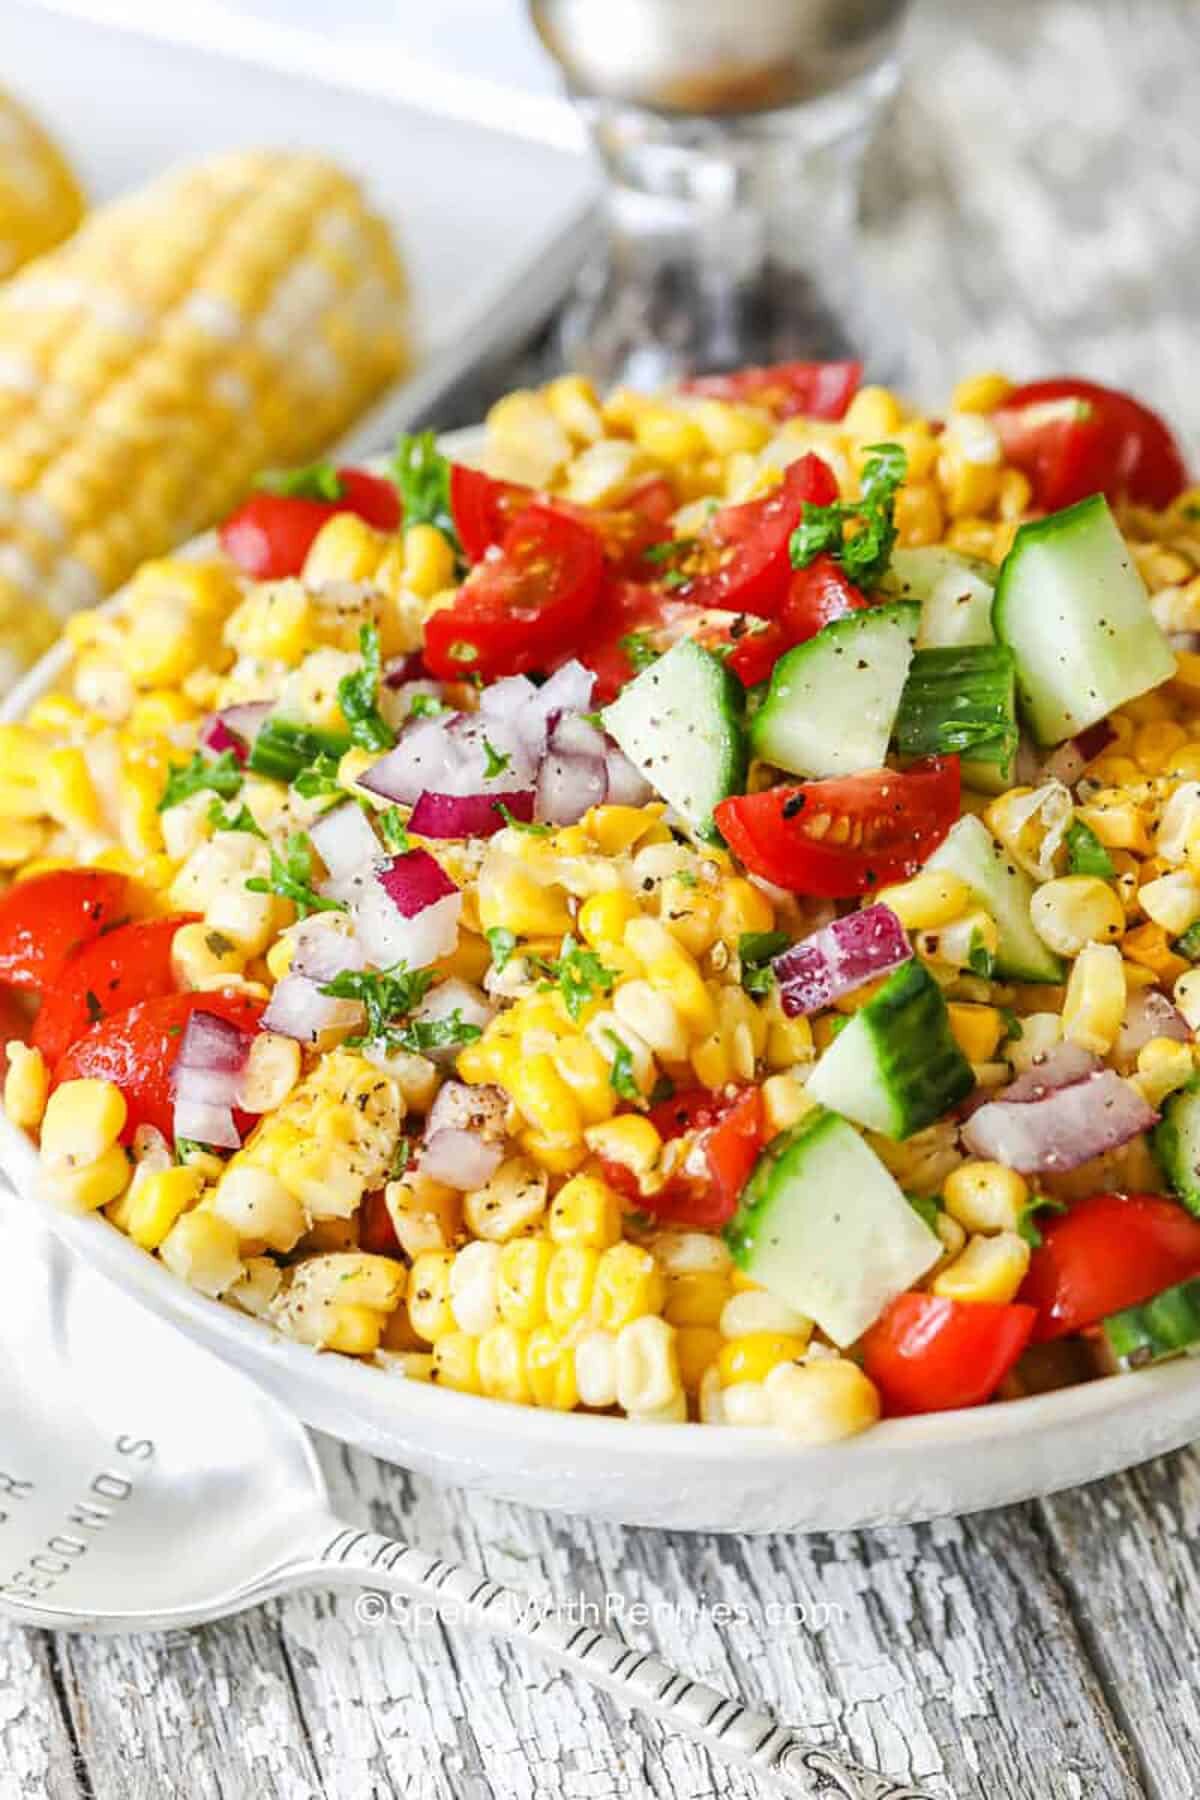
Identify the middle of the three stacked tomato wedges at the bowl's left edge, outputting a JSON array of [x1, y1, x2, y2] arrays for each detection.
[[32, 913, 196, 1067]]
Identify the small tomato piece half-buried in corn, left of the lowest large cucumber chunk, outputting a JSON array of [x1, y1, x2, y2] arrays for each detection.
[[604, 1087, 765, 1229]]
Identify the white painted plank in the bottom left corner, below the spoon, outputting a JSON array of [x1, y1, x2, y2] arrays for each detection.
[[0, 1618, 81, 1800]]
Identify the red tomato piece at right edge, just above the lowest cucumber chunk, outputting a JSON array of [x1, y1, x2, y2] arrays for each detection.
[[1016, 1193, 1200, 1341]]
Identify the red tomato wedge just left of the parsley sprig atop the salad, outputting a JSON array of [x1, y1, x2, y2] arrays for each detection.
[[673, 452, 838, 619]]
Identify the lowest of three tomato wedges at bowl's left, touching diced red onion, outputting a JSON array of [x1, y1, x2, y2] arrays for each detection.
[[54, 992, 263, 1143]]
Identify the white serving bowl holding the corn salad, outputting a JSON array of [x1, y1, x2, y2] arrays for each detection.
[[0, 434, 1200, 1532]]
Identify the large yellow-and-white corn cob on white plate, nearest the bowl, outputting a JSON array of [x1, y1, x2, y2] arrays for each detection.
[[0, 151, 407, 679]]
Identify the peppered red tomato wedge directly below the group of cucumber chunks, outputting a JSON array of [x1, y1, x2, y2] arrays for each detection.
[[716, 756, 959, 900]]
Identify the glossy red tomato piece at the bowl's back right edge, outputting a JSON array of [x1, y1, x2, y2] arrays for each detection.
[[995, 376, 1187, 513]]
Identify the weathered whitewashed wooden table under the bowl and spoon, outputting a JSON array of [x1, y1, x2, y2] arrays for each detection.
[[0, 0, 1200, 1800]]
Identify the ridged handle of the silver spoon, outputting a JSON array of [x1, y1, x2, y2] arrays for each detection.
[[314, 1526, 937, 1800]]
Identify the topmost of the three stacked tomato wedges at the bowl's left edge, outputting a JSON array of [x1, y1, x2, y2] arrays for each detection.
[[0, 869, 130, 992]]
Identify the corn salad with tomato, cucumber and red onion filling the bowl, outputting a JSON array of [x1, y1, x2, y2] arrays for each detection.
[[0, 374, 1200, 1444]]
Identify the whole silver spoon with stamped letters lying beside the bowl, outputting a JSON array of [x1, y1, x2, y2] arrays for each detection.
[[0, 1201, 934, 1800]]
